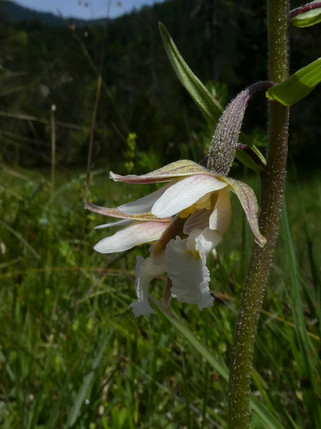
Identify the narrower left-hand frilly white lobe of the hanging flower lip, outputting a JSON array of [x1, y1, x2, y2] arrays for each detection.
[[130, 256, 164, 317]]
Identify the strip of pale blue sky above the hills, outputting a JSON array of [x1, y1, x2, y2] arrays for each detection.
[[14, 0, 163, 19]]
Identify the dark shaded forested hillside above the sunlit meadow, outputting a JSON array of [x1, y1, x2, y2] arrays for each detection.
[[0, 0, 321, 171]]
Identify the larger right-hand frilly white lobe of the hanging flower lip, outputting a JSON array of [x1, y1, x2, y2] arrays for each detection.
[[165, 237, 214, 310]]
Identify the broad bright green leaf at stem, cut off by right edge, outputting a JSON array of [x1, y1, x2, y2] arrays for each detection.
[[266, 58, 321, 106]]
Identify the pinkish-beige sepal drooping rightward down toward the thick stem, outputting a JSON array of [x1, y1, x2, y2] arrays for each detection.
[[222, 177, 266, 247]]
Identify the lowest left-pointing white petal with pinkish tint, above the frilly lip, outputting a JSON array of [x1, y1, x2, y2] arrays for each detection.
[[94, 222, 167, 254]]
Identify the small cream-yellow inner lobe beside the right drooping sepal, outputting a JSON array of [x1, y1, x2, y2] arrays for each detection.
[[209, 189, 232, 235]]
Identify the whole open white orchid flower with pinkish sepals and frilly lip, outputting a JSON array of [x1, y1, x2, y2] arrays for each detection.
[[85, 160, 266, 316]]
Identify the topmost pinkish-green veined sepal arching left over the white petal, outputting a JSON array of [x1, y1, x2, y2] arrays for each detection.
[[110, 159, 213, 183]]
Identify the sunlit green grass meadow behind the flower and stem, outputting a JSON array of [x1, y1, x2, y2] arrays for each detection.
[[0, 162, 321, 429]]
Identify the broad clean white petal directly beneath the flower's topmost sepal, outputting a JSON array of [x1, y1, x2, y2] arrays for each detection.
[[152, 174, 227, 218]]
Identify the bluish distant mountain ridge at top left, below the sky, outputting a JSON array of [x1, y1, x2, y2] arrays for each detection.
[[0, 0, 105, 26]]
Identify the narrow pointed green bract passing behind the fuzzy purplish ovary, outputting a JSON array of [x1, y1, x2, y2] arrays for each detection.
[[159, 22, 266, 172]]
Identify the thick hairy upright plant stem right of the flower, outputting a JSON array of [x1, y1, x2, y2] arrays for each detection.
[[228, 0, 289, 429]]
